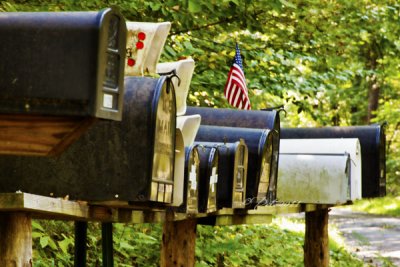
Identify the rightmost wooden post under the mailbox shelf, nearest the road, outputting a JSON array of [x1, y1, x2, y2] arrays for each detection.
[[304, 207, 329, 267]]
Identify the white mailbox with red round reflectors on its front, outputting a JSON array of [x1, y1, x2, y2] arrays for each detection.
[[125, 21, 171, 76]]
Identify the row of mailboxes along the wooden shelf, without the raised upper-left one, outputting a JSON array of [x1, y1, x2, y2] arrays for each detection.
[[0, 77, 385, 212]]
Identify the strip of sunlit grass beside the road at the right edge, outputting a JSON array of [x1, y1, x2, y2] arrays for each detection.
[[346, 196, 400, 217]]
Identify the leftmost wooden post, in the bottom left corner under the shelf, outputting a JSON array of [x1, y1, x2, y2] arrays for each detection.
[[0, 212, 32, 267]]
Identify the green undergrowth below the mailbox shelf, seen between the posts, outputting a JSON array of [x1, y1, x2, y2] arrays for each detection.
[[32, 220, 362, 267]]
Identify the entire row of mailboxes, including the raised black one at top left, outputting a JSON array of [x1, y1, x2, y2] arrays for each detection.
[[0, 9, 386, 213]]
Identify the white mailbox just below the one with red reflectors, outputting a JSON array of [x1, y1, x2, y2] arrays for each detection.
[[157, 58, 194, 116]]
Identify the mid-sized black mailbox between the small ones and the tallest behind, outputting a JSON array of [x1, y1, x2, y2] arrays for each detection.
[[196, 125, 278, 207]]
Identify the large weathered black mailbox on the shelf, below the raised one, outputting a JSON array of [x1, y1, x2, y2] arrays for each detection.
[[0, 77, 176, 204]]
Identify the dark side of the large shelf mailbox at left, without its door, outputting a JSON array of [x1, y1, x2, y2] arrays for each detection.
[[0, 76, 169, 201]]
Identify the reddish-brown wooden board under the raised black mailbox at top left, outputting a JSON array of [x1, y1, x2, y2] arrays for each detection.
[[0, 114, 95, 156]]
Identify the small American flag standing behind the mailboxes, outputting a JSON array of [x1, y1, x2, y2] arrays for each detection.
[[224, 44, 251, 109]]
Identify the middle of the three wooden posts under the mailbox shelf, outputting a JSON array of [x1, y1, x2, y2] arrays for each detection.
[[160, 219, 197, 267]]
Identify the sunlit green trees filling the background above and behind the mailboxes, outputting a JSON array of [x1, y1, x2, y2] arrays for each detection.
[[0, 0, 400, 266]]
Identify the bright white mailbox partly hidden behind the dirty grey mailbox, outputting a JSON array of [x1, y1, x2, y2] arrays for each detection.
[[278, 138, 362, 201]]
